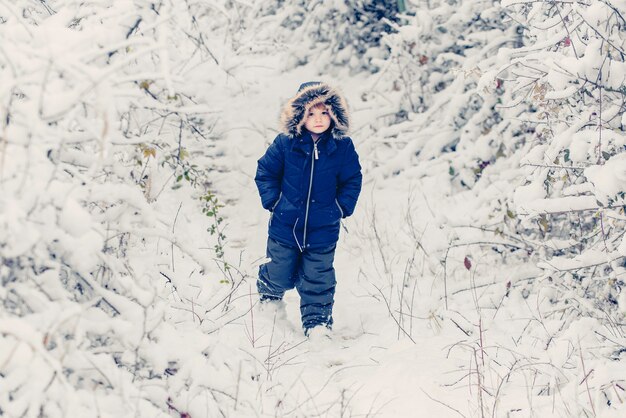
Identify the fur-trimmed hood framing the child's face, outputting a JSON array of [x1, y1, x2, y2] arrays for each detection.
[[280, 82, 350, 139]]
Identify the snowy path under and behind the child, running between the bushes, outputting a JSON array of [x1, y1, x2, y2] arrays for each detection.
[[196, 63, 478, 416]]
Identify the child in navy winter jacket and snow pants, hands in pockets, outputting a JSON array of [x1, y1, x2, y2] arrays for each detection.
[[255, 82, 362, 336]]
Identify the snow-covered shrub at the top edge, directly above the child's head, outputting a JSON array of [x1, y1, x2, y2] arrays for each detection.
[[241, 0, 403, 74]]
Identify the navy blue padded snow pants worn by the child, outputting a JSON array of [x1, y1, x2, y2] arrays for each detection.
[[257, 238, 337, 333]]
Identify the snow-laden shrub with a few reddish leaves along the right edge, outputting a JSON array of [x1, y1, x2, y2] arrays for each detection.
[[481, 0, 626, 315]]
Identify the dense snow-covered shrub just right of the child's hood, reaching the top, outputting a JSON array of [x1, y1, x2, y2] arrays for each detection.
[[365, 0, 527, 184]]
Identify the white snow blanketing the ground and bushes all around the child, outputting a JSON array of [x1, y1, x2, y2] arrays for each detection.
[[0, 0, 626, 417]]
